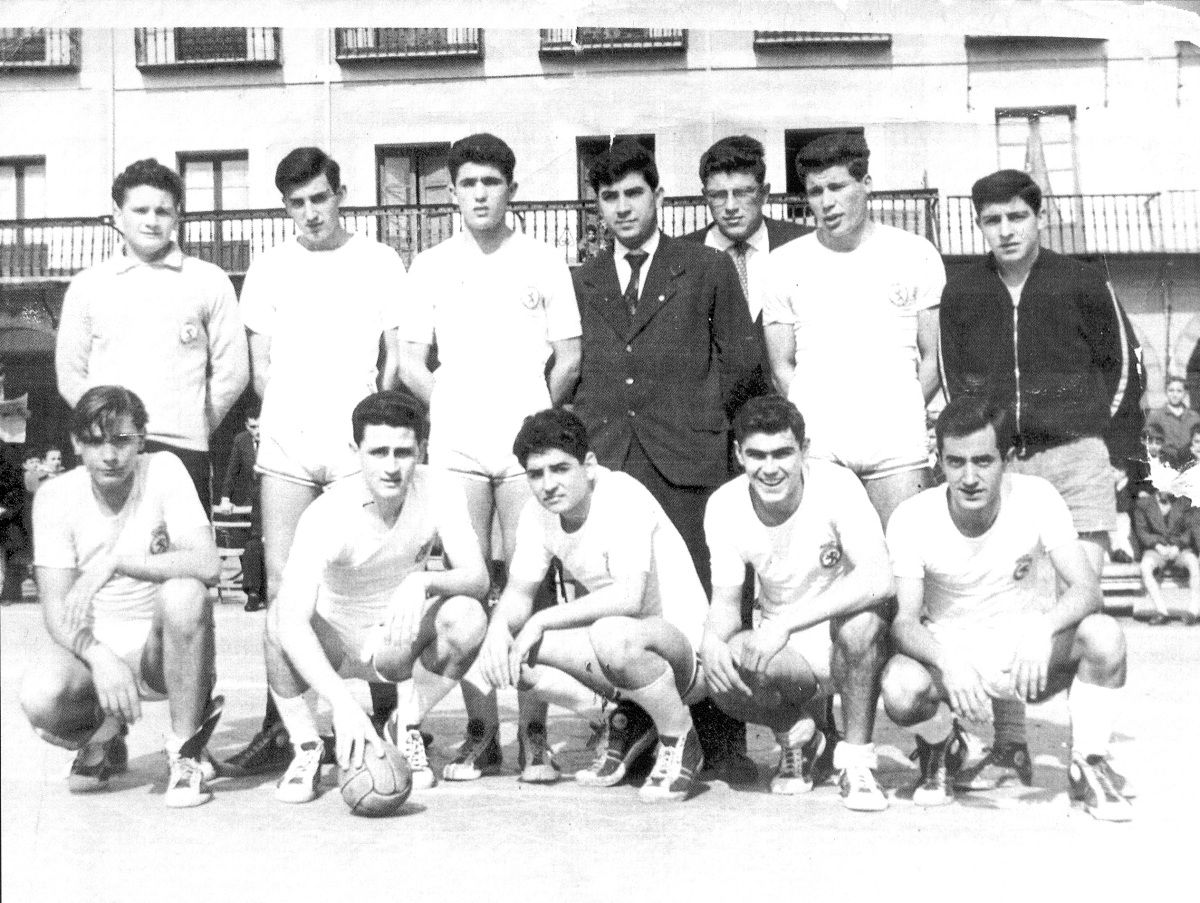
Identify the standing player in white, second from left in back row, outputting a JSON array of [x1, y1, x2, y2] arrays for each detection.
[[230, 148, 407, 771]]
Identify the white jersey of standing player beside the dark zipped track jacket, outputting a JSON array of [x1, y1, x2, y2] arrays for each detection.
[[763, 223, 946, 437]]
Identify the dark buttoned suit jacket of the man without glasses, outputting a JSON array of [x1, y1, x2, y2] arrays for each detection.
[[574, 235, 762, 486]]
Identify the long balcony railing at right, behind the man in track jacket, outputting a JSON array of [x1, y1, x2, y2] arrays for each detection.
[[941, 190, 1200, 255]]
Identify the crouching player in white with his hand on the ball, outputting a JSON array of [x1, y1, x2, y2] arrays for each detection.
[[265, 391, 487, 802]]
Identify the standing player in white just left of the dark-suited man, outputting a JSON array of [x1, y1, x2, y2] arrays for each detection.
[[400, 133, 592, 781]]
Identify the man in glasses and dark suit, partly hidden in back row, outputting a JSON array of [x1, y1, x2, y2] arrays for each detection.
[[683, 134, 812, 784]]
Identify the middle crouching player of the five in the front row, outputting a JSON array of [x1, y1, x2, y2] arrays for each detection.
[[480, 409, 707, 802]]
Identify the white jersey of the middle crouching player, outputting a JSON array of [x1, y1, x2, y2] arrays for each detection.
[[511, 467, 708, 650]]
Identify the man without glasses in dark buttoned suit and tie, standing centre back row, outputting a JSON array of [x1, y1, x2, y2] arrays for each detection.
[[575, 140, 763, 782]]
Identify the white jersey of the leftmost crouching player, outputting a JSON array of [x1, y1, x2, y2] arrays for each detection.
[[34, 452, 209, 622]]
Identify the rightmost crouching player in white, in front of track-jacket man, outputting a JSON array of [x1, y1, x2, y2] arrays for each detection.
[[883, 399, 1133, 821]]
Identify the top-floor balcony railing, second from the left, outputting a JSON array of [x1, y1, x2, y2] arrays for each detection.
[[133, 28, 280, 68]]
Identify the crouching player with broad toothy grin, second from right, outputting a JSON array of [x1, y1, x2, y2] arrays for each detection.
[[701, 395, 892, 812]]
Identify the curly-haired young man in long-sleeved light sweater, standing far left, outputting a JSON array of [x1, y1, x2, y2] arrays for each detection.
[[54, 159, 250, 510]]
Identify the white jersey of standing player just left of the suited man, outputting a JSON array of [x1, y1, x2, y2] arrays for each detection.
[[400, 232, 581, 448]]
